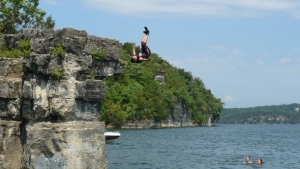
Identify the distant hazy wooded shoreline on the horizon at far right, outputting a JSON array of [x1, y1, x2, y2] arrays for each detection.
[[219, 103, 300, 124]]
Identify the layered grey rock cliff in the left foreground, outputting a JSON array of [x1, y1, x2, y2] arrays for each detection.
[[0, 28, 122, 169]]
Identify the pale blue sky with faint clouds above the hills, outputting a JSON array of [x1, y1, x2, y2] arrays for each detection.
[[39, 0, 300, 108]]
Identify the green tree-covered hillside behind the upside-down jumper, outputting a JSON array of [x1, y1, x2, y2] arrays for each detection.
[[101, 42, 223, 127]]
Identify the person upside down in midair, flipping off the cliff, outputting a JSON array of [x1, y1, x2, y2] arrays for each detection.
[[130, 27, 151, 63]]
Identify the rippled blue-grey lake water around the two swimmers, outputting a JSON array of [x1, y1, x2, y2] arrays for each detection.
[[106, 124, 300, 169]]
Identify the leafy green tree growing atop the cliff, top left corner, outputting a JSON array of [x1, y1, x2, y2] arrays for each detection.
[[0, 0, 55, 34]]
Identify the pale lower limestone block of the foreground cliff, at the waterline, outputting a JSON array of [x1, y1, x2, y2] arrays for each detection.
[[24, 121, 107, 169]]
